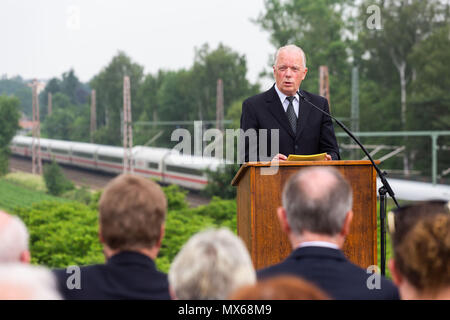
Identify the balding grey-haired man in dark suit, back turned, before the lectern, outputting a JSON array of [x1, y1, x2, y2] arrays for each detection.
[[257, 167, 399, 299]]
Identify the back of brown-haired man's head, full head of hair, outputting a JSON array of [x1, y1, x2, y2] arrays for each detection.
[[99, 174, 167, 256]]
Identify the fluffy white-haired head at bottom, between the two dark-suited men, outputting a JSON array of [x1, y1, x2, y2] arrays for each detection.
[[169, 228, 256, 300]]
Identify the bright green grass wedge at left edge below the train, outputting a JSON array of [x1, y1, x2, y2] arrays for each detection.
[[0, 178, 68, 212]]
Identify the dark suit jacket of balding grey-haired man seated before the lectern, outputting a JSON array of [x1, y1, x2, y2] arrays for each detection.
[[257, 247, 399, 300]]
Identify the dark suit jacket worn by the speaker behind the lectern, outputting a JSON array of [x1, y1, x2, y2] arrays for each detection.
[[241, 85, 340, 162]]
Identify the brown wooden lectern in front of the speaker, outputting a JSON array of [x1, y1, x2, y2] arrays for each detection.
[[232, 160, 377, 269]]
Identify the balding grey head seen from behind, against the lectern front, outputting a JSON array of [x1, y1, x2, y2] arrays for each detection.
[[283, 167, 352, 236]]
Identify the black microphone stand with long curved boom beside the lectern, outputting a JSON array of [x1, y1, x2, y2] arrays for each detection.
[[297, 90, 399, 276]]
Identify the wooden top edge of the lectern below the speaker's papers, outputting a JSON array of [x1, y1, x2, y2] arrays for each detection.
[[231, 160, 381, 186]]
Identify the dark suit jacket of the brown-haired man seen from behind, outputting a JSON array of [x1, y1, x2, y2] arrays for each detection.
[[53, 252, 170, 300]]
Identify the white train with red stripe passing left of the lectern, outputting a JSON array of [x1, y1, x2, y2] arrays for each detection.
[[11, 136, 223, 190]]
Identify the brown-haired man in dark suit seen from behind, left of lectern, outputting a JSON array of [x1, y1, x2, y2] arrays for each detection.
[[54, 175, 170, 300]]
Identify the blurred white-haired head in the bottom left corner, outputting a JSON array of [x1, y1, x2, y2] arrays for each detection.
[[0, 263, 61, 300]]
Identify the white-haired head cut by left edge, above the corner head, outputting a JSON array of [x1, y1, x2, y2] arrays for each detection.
[[0, 211, 30, 263]]
